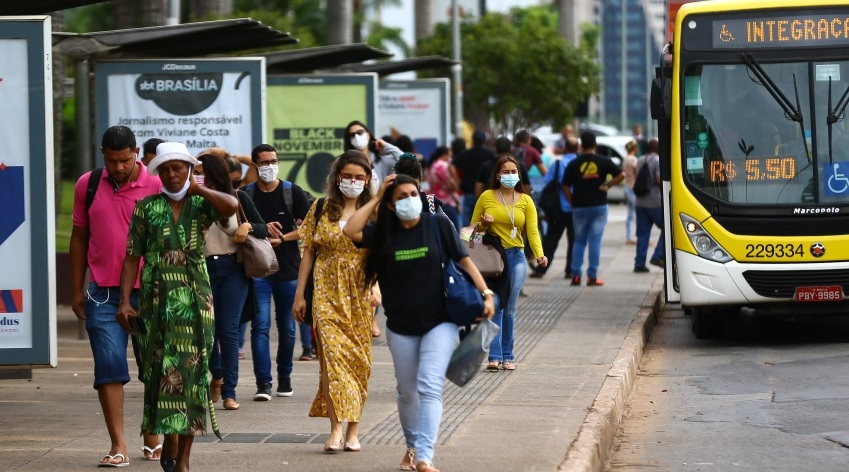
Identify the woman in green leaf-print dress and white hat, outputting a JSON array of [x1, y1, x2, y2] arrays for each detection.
[[116, 143, 238, 472]]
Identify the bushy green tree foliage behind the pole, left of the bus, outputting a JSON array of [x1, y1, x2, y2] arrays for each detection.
[[417, 7, 600, 129]]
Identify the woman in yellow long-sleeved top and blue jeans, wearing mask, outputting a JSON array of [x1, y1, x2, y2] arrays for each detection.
[[472, 154, 548, 371]]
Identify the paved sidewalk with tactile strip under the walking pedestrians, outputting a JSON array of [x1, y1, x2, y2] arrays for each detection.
[[0, 206, 662, 472]]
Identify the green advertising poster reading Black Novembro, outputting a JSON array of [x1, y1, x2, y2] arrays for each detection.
[[266, 74, 377, 196]]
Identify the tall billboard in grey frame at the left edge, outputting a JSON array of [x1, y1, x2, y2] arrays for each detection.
[[0, 16, 57, 367]]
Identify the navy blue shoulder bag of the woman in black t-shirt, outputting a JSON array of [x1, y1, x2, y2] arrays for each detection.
[[430, 215, 484, 326]]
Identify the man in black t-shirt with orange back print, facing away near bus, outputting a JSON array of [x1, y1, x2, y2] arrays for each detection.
[[563, 131, 625, 287]]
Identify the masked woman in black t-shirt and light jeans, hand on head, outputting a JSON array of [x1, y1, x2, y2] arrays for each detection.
[[343, 175, 495, 472]]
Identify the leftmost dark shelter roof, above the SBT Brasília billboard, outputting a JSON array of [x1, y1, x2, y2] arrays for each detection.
[[53, 18, 298, 59]]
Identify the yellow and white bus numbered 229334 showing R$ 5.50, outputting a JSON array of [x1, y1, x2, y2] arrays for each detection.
[[651, 0, 849, 338]]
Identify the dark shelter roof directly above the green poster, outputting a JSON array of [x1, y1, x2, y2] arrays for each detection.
[[256, 43, 392, 74]]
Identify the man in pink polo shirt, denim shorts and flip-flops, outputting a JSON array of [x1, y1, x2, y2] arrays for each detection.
[[70, 126, 161, 467]]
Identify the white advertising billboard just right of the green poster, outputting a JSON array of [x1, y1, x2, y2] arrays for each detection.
[[375, 79, 450, 158]]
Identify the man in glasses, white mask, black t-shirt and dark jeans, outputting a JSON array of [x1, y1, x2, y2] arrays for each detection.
[[245, 144, 310, 401]]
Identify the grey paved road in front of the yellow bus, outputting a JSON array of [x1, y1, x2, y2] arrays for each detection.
[[608, 307, 849, 472]]
